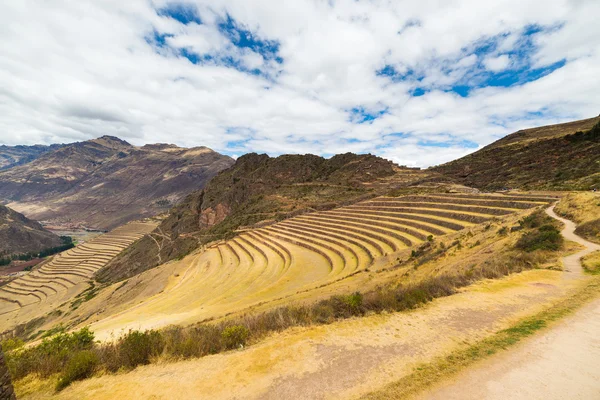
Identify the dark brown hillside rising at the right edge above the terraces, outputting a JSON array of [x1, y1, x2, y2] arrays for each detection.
[[431, 117, 600, 190]]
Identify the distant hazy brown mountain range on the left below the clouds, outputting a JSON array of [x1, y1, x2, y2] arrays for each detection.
[[0, 136, 234, 229]]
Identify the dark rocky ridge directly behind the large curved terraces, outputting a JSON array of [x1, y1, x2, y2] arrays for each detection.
[[97, 153, 429, 281]]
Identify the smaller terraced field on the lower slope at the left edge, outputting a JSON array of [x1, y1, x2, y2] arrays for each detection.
[[0, 222, 156, 313]]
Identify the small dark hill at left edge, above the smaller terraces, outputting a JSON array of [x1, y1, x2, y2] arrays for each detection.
[[0, 205, 62, 255]]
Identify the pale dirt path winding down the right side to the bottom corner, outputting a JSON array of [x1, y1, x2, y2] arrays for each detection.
[[420, 207, 600, 400]]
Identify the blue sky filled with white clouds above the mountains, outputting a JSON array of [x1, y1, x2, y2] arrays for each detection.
[[0, 0, 600, 167]]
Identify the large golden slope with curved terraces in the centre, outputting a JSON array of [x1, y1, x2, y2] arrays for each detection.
[[85, 194, 556, 338]]
